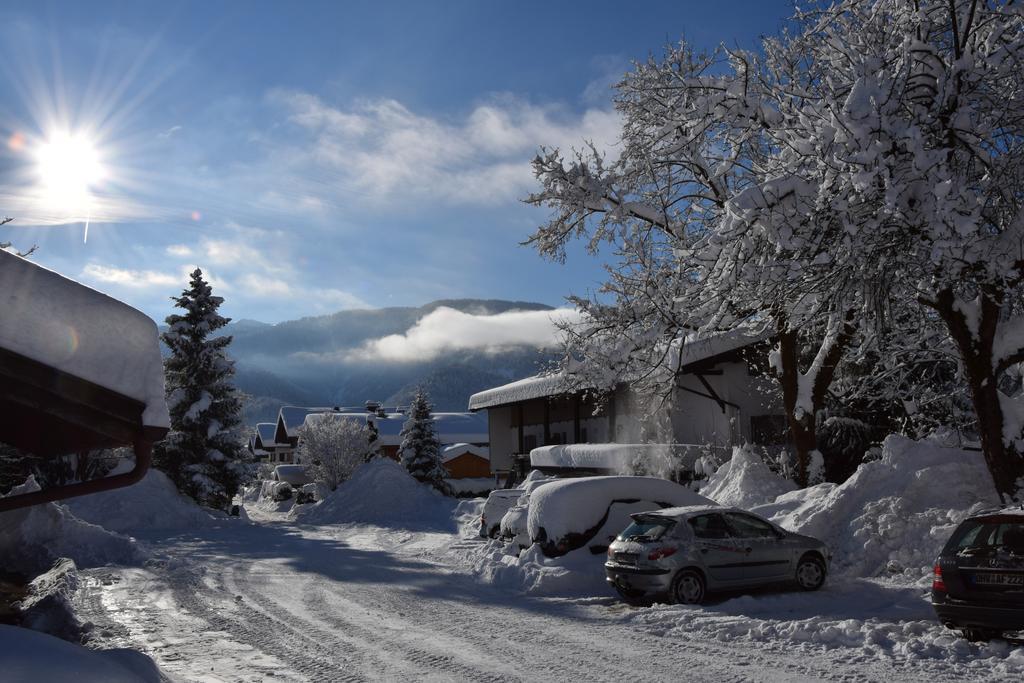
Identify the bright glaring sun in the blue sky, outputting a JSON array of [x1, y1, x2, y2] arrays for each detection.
[[35, 131, 106, 201]]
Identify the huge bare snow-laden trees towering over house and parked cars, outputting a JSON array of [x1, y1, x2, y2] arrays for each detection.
[[530, 0, 1024, 495]]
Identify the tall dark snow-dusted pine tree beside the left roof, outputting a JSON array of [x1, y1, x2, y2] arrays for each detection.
[[154, 268, 249, 510]]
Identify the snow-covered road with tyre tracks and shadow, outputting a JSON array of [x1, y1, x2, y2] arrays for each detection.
[[70, 515, 1015, 681]]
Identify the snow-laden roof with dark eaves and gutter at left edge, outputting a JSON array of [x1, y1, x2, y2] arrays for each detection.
[[0, 250, 170, 511]]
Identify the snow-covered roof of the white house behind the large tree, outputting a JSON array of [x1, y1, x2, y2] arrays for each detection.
[[469, 330, 772, 411]]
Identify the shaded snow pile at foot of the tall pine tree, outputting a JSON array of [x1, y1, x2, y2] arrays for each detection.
[[65, 461, 212, 533]]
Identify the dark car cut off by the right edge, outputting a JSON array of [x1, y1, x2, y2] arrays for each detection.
[[932, 509, 1024, 640]]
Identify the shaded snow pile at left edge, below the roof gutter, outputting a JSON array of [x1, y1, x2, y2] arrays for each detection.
[[0, 477, 141, 574]]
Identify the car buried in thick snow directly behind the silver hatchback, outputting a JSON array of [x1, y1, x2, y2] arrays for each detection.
[[526, 476, 712, 557]]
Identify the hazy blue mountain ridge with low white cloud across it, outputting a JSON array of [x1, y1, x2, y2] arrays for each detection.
[[212, 299, 573, 425]]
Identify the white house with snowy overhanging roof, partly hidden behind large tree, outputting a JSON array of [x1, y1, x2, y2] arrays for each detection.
[[469, 327, 786, 479]]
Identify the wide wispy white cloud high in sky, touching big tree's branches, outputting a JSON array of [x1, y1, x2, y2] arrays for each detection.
[[269, 90, 621, 204]]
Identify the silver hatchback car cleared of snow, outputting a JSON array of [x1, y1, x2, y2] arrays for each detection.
[[604, 506, 831, 603]]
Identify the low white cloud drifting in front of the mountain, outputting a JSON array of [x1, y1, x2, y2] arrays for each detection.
[[344, 307, 580, 362]]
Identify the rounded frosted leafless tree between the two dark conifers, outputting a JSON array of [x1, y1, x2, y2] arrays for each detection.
[[299, 413, 373, 490]]
